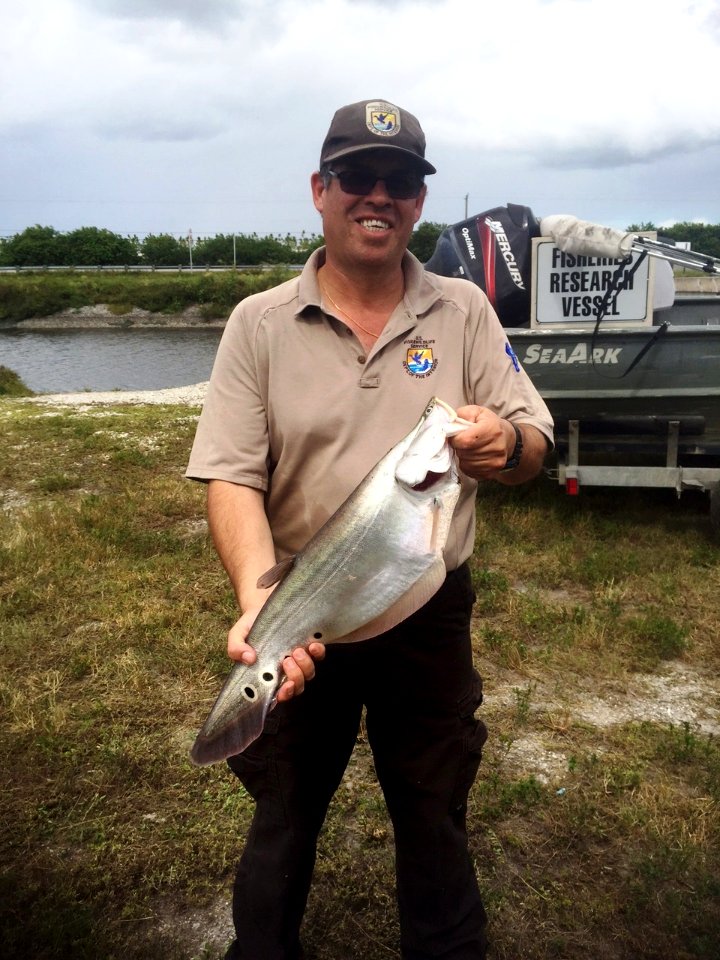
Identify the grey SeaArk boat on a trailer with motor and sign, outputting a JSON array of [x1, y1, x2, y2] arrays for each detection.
[[425, 204, 720, 523]]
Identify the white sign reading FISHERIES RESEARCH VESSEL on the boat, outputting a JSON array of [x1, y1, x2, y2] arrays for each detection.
[[530, 237, 653, 329]]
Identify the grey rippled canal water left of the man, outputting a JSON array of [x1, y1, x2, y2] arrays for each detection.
[[0, 327, 222, 393]]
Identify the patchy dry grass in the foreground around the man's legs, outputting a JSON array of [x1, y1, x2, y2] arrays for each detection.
[[0, 398, 720, 960]]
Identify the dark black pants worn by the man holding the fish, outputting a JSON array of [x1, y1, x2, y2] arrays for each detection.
[[227, 566, 487, 960]]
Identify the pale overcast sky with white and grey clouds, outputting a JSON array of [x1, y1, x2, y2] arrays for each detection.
[[0, 0, 720, 238]]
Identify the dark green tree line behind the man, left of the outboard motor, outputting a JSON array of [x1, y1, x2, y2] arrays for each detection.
[[0, 221, 445, 267]]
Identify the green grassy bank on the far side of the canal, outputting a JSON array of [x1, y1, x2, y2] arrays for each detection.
[[0, 267, 293, 327]]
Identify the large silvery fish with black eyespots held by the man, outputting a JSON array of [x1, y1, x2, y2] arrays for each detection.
[[190, 397, 471, 766]]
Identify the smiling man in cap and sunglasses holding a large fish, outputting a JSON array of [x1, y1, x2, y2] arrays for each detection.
[[188, 101, 552, 960]]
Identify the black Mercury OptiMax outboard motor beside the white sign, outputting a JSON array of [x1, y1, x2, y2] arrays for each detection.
[[425, 203, 540, 327]]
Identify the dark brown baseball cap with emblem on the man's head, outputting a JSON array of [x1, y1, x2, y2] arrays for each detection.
[[320, 100, 437, 174]]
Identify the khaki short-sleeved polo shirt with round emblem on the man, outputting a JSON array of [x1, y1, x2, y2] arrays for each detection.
[[186, 249, 552, 570]]
